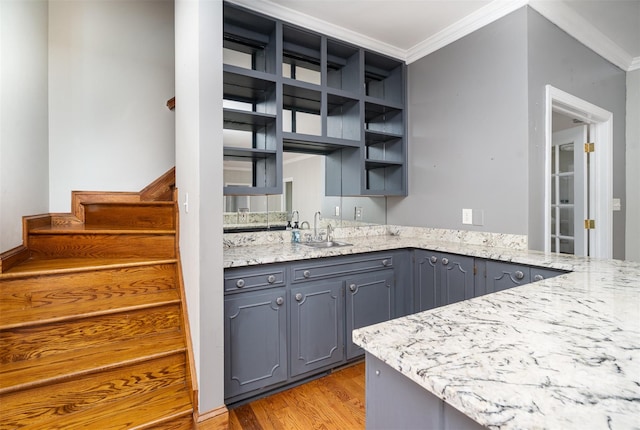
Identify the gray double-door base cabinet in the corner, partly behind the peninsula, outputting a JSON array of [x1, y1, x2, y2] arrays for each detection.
[[414, 250, 475, 312]]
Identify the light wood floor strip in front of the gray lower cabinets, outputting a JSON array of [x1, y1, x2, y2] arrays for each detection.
[[229, 362, 365, 430]]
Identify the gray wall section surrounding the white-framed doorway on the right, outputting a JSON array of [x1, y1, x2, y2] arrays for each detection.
[[527, 8, 626, 259]]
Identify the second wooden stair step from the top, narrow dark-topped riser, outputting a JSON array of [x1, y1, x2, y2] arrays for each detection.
[[27, 225, 176, 259]]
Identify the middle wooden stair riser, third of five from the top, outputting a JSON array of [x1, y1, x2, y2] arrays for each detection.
[[0, 264, 180, 329]]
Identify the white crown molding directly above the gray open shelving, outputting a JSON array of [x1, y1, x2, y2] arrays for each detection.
[[227, 0, 406, 60]]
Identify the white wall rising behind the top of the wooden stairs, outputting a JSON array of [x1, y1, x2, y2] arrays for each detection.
[[49, 0, 175, 212]]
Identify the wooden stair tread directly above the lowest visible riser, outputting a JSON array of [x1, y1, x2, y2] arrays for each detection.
[[0, 330, 185, 394]]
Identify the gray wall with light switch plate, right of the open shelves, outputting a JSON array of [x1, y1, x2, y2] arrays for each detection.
[[387, 9, 528, 234]]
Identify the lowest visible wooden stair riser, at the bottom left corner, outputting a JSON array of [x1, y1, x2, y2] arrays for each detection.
[[0, 353, 192, 429]]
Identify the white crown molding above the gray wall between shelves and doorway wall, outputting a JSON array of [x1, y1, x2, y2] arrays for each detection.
[[405, 0, 528, 64]]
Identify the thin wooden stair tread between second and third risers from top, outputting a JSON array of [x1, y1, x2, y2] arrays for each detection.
[[0, 257, 177, 281]]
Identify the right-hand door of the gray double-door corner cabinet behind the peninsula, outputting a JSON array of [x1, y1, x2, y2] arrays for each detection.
[[437, 254, 474, 306]]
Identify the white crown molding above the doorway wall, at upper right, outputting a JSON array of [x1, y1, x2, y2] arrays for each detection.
[[529, 0, 638, 71]]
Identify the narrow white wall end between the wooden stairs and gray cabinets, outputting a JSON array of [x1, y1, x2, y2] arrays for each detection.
[[175, 0, 224, 413]]
